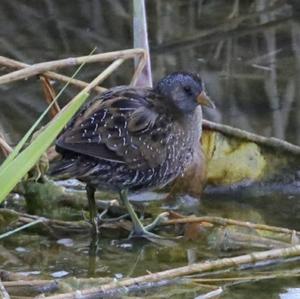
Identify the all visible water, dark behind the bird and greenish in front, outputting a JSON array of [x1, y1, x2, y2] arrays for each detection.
[[0, 0, 300, 299]]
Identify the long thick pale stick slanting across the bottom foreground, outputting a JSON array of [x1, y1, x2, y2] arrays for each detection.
[[47, 245, 300, 299]]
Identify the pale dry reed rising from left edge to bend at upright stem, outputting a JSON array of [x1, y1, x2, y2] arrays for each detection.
[[0, 49, 145, 84]]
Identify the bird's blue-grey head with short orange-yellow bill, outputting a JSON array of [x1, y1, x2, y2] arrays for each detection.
[[156, 72, 215, 113]]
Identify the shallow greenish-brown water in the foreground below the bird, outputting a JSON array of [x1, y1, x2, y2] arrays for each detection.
[[0, 189, 300, 298]]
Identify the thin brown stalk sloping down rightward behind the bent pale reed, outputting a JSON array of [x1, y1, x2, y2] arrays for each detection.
[[0, 56, 106, 93]]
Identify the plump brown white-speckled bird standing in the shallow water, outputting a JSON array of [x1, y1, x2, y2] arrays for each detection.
[[51, 72, 215, 239]]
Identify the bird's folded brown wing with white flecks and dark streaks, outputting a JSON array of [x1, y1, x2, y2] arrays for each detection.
[[56, 87, 171, 168]]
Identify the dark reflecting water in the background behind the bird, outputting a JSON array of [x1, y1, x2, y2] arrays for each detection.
[[0, 0, 300, 144]]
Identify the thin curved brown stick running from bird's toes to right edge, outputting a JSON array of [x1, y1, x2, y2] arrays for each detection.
[[161, 216, 300, 236]]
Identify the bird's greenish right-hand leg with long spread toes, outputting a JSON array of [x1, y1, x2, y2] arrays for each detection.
[[120, 189, 165, 240]]
